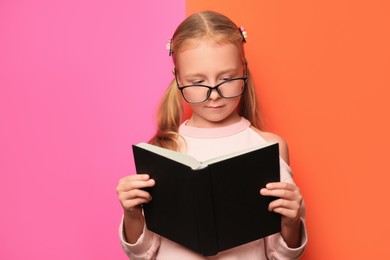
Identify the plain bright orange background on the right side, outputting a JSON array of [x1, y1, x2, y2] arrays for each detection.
[[186, 0, 390, 260]]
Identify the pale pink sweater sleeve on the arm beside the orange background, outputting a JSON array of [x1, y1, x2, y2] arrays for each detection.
[[264, 159, 307, 260]]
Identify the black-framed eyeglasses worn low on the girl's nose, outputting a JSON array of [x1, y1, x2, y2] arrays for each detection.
[[175, 64, 248, 104]]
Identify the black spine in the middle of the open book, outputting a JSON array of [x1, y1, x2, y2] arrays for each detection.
[[193, 167, 219, 256]]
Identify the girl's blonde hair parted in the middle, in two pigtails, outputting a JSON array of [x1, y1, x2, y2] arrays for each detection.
[[149, 11, 261, 150]]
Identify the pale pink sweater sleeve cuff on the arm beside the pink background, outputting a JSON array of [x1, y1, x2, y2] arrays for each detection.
[[119, 216, 160, 260]]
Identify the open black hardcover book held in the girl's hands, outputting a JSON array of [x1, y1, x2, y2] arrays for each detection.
[[132, 143, 281, 256]]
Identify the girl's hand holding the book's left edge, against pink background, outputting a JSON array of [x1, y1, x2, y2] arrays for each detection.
[[116, 174, 155, 217]]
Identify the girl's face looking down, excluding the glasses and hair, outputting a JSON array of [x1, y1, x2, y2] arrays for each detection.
[[175, 41, 245, 127]]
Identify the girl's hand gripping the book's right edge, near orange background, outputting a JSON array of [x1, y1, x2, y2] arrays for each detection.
[[260, 182, 303, 225]]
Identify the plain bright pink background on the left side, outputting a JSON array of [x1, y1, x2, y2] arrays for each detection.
[[0, 0, 185, 260]]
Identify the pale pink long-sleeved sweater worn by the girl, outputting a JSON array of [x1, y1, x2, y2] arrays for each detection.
[[119, 118, 307, 260]]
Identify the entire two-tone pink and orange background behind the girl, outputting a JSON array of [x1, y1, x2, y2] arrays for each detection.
[[0, 0, 390, 260]]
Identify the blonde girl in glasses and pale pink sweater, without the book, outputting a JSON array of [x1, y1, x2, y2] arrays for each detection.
[[117, 11, 307, 259]]
